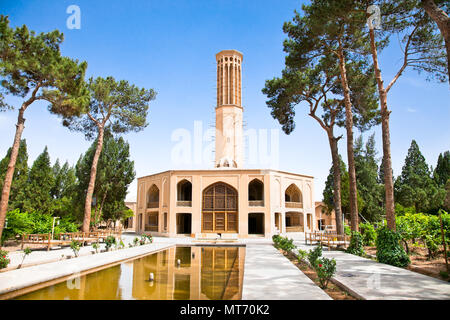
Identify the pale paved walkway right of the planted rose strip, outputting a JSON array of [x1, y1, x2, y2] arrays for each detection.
[[294, 241, 450, 300]]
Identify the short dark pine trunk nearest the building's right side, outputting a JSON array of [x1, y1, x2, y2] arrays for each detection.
[[328, 132, 344, 235]]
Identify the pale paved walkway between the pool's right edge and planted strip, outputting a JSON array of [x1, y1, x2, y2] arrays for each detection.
[[242, 243, 331, 300]]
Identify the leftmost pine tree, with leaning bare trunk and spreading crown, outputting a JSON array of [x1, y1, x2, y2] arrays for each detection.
[[0, 15, 88, 238]]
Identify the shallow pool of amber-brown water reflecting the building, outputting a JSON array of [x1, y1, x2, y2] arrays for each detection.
[[17, 246, 245, 300]]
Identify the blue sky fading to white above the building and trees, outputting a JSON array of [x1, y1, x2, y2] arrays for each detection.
[[0, 0, 450, 200]]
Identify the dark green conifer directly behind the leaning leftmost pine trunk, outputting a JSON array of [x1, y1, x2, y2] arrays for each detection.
[[0, 139, 28, 210]]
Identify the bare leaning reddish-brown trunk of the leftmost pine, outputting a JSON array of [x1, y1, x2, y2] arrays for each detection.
[[0, 104, 26, 242]]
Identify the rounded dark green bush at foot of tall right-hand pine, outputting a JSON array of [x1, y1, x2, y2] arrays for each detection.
[[376, 226, 411, 267]]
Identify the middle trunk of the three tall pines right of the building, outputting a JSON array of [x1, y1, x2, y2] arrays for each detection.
[[338, 45, 358, 231]]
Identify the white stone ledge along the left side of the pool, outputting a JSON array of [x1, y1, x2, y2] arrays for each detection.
[[0, 242, 176, 300]]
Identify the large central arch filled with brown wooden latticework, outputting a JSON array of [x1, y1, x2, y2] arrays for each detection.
[[202, 182, 238, 233]]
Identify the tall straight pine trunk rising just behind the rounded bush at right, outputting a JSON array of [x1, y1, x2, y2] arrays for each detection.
[[369, 29, 396, 231]]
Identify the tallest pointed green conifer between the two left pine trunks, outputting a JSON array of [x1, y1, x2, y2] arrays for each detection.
[[17, 147, 55, 214]]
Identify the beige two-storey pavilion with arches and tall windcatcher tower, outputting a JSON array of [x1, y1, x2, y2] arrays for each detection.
[[134, 50, 317, 238]]
